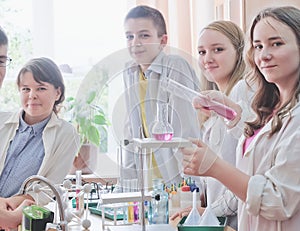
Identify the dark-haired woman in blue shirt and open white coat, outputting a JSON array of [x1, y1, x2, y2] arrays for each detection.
[[0, 57, 80, 228]]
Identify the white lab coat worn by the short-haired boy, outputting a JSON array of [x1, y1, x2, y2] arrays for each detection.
[[122, 52, 200, 186]]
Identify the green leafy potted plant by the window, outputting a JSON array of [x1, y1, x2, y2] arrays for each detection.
[[66, 90, 109, 174]]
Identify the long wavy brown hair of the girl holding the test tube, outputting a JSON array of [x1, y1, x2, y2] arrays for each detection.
[[245, 6, 300, 137]]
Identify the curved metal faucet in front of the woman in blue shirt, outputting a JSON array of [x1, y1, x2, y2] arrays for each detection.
[[20, 175, 68, 231]]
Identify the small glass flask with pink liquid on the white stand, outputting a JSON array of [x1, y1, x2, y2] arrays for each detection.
[[152, 101, 173, 141]]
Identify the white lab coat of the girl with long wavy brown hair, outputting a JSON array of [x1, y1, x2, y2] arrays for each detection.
[[237, 103, 300, 231]]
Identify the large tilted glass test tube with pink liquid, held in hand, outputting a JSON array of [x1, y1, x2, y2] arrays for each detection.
[[161, 79, 236, 120]]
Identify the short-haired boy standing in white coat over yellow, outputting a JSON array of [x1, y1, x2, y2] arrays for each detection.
[[122, 5, 200, 187]]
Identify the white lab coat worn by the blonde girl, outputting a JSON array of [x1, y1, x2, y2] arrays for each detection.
[[203, 80, 254, 229]]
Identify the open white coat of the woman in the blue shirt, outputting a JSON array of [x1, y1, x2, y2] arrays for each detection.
[[0, 112, 80, 204]]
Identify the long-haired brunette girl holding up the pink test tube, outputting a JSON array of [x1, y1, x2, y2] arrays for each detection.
[[182, 6, 300, 231]]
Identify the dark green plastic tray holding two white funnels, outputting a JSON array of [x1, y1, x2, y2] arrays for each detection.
[[177, 217, 227, 231]]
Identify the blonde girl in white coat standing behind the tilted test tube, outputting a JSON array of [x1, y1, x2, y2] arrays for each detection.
[[171, 20, 254, 230]]
